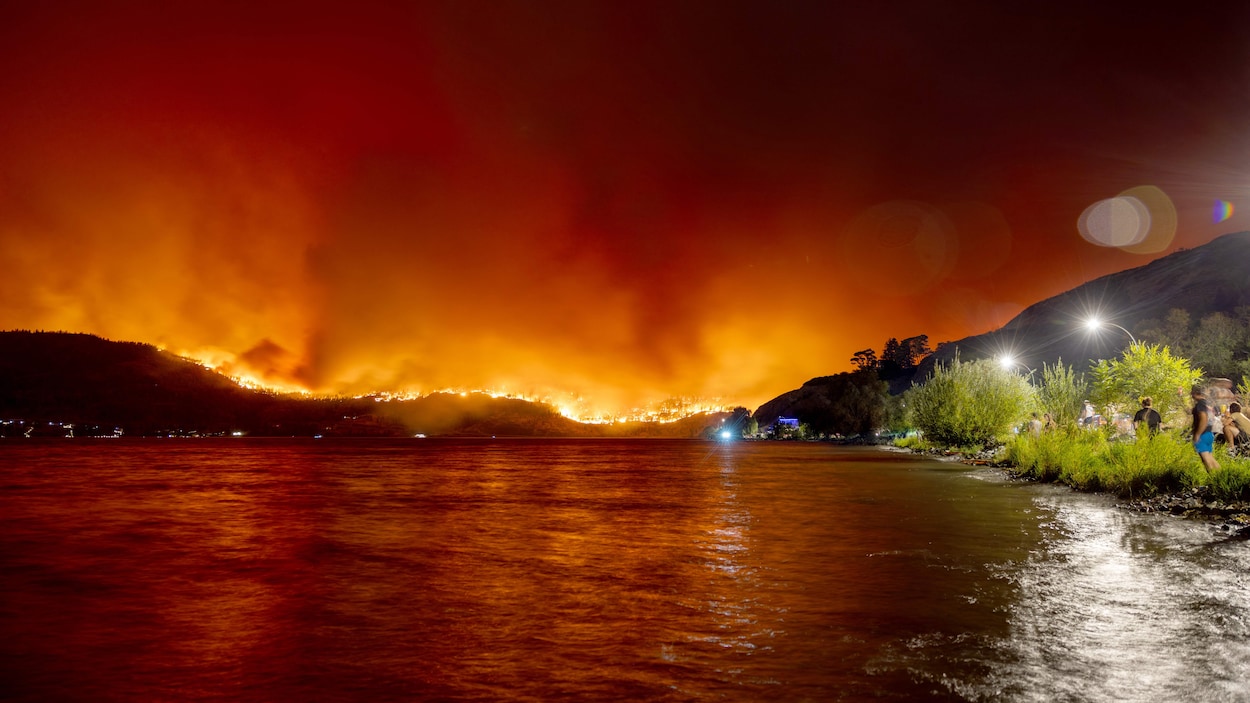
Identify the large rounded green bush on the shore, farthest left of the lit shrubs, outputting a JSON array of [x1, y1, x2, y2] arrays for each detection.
[[906, 357, 1035, 447]]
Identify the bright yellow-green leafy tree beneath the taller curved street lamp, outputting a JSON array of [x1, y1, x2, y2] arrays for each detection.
[[1090, 343, 1203, 417]]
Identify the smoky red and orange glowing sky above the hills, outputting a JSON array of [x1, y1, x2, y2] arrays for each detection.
[[0, 0, 1250, 408]]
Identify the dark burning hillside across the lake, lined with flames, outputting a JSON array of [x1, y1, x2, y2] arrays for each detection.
[[0, 331, 721, 437]]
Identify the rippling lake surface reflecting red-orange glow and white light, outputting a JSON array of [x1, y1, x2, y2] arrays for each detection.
[[0, 439, 1250, 702]]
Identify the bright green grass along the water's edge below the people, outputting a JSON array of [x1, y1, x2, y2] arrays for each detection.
[[1003, 429, 1250, 502]]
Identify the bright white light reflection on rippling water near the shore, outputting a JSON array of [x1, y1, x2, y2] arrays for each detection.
[[998, 495, 1250, 702]]
